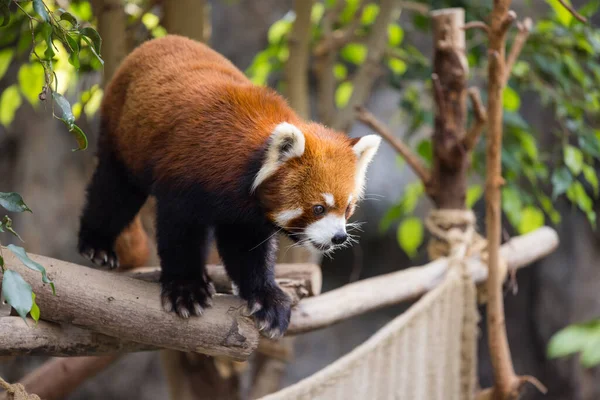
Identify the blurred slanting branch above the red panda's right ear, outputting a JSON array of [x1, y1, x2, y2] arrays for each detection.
[[333, 0, 400, 130]]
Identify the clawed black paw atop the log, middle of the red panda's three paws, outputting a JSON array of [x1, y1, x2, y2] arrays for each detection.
[[161, 280, 215, 318]]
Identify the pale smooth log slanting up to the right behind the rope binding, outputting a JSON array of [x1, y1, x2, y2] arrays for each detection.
[[288, 227, 558, 335]]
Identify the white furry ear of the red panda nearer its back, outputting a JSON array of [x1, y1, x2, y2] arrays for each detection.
[[251, 122, 306, 192]]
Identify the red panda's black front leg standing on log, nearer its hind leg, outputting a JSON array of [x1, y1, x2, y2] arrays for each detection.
[[156, 198, 215, 318]]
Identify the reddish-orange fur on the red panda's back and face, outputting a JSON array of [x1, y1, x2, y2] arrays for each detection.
[[102, 36, 357, 228]]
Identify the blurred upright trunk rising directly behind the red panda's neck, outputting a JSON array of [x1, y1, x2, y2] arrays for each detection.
[[285, 0, 313, 118]]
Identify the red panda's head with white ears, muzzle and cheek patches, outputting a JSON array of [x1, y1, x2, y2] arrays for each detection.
[[252, 122, 381, 252]]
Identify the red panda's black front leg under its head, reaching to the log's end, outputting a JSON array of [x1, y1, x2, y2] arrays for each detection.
[[216, 225, 291, 338]]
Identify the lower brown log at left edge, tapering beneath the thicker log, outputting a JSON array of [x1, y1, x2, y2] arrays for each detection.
[[0, 317, 153, 357]]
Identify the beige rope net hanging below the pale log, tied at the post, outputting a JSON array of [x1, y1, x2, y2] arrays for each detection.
[[262, 252, 478, 400]]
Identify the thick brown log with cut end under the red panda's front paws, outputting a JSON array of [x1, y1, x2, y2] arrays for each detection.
[[0, 250, 259, 360]]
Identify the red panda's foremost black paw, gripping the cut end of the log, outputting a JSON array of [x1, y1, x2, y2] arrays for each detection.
[[248, 284, 292, 339]]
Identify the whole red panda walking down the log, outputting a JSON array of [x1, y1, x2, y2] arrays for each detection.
[[78, 36, 380, 337]]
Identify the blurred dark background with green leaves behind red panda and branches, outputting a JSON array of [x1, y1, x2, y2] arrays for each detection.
[[0, 0, 600, 400]]
